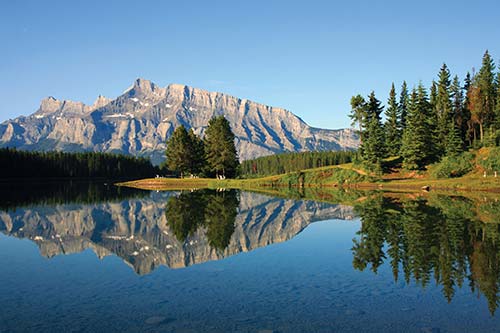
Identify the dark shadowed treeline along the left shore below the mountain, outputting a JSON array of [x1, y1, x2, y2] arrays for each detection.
[[0, 148, 157, 179]]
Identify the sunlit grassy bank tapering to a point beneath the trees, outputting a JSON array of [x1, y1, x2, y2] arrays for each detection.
[[117, 149, 500, 193]]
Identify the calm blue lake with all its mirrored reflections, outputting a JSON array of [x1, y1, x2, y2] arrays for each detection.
[[0, 183, 500, 332]]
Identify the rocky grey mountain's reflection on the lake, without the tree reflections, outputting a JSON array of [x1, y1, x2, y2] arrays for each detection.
[[0, 191, 355, 275]]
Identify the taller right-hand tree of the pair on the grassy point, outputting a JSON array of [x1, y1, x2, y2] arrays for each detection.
[[204, 116, 239, 177]]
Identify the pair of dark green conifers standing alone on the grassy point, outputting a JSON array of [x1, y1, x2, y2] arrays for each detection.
[[165, 116, 239, 177]]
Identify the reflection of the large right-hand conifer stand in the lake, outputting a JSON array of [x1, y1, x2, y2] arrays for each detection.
[[352, 194, 500, 314]]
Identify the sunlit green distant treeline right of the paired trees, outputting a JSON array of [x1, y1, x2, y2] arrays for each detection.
[[241, 151, 356, 177]]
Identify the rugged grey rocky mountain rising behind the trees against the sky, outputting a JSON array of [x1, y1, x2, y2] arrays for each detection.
[[0, 79, 359, 163]]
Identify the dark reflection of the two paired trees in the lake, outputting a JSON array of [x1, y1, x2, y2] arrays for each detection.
[[165, 190, 239, 250]]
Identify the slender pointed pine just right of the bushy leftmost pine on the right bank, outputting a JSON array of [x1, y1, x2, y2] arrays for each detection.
[[384, 83, 401, 156]]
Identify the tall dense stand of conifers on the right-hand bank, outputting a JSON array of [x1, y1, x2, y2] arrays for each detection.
[[350, 51, 500, 174]]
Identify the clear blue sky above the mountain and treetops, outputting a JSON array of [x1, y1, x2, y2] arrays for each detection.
[[0, 0, 500, 128]]
